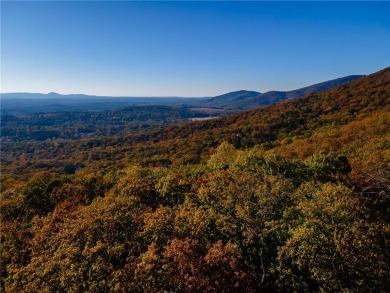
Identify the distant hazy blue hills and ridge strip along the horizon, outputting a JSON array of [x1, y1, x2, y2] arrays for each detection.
[[0, 75, 362, 115]]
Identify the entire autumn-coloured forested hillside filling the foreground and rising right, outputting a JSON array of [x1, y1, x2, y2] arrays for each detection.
[[0, 68, 390, 292]]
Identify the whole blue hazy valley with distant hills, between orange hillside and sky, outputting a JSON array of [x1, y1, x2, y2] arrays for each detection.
[[1, 75, 362, 142]]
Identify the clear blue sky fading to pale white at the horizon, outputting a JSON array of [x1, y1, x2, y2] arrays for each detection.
[[1, 1, 390, 96]]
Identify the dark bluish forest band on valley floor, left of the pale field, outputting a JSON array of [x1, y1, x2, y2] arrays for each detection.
[[1, 106, 232, 142]]
